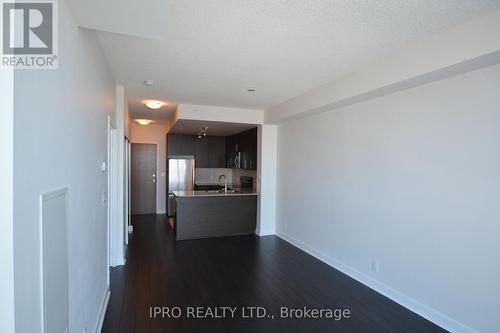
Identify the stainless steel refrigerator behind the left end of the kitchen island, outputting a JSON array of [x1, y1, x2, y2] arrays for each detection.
[[168, 156, 195, 216]]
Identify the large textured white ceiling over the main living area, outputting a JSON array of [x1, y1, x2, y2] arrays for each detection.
[[90, 0, 500, 114]]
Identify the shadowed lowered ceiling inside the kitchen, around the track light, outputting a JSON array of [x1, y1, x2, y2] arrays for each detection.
[[169, 119, 256, 136]]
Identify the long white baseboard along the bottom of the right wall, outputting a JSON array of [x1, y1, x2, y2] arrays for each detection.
[[276, 231, 477, 333]]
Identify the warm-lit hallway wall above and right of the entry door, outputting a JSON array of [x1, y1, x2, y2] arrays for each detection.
[[130, 122, 167, 214]]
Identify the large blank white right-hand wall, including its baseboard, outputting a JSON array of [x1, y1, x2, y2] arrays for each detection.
[[277, 65, 500, 332]]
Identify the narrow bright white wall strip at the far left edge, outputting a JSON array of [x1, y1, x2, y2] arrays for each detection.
[[0, 65, 15, 333]]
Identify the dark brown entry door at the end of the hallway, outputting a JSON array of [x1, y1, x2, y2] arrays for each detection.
[[130, 143, 157, 215]]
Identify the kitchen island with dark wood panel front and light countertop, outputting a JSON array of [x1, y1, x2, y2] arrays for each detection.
[[173, 190, 259, 240]]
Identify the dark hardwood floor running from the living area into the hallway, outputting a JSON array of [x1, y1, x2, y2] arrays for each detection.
[[102, 215, 445, 333]]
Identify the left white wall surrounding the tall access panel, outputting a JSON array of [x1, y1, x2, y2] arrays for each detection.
[[14, 1, 114, 332]]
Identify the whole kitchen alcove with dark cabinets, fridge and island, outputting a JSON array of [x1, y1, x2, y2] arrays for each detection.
[[167, 120, 259, 240]]
